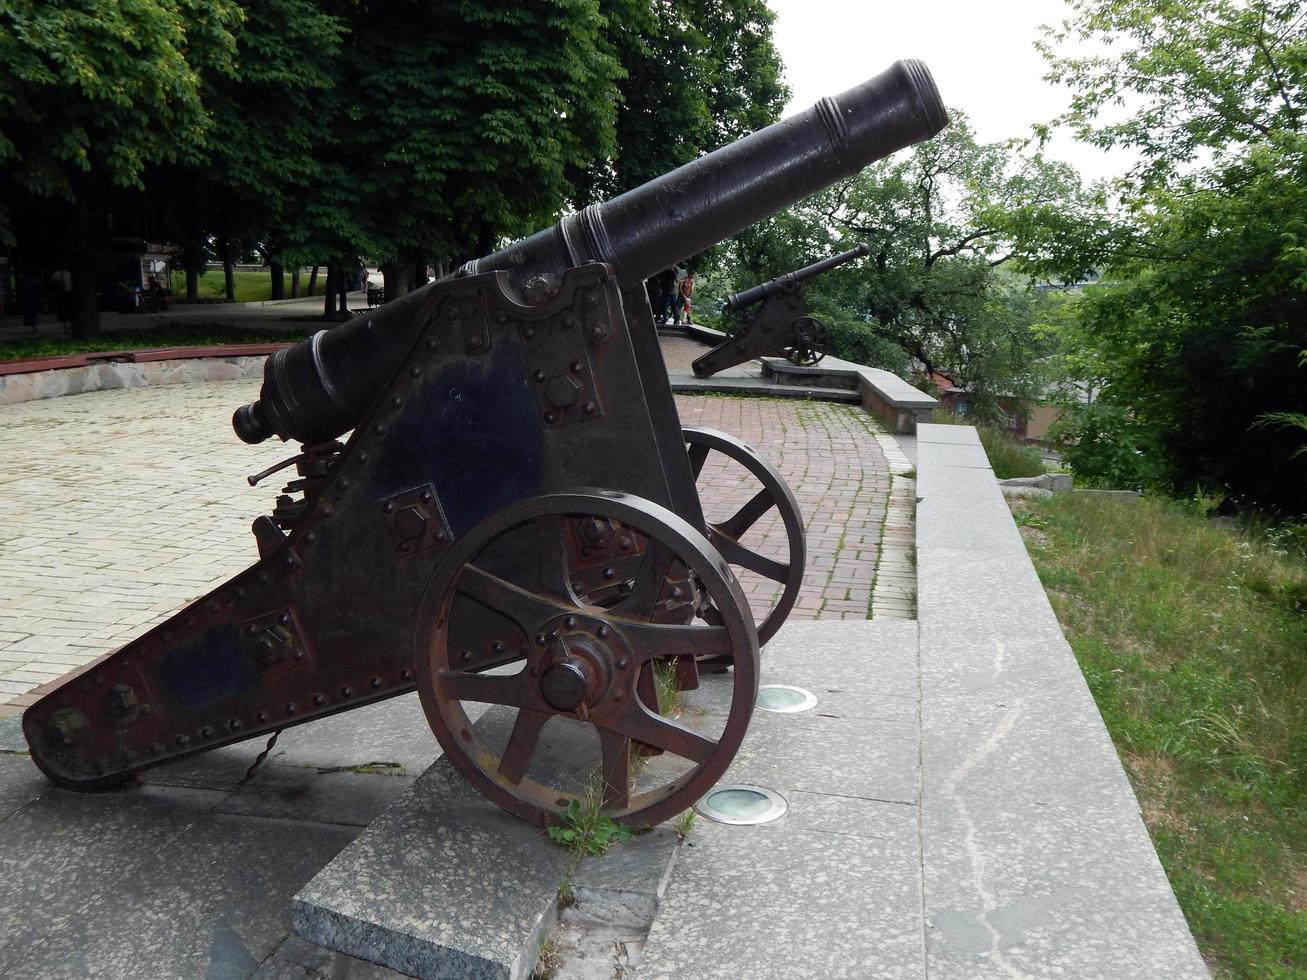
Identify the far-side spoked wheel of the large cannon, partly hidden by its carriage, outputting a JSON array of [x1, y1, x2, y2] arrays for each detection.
[[681, 429, 808, 644]]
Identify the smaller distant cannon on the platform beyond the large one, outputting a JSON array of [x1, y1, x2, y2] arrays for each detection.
[[690, 244, 870, 378]]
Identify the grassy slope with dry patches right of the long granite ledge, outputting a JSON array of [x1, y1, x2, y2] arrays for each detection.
[[1014, 494, 1307, 979]]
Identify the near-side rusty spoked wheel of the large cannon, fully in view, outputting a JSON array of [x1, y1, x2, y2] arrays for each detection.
[[416, 489, 758, 826]]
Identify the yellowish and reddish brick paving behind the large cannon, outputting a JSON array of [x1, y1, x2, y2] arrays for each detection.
[[0, 338, 914, 713]]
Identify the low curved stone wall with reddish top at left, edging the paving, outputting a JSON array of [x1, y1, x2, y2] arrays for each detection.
[[0, 354, 267, 405]]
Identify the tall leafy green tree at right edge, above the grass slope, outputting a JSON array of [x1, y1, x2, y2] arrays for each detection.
[[1029, 0, 1307, 514]]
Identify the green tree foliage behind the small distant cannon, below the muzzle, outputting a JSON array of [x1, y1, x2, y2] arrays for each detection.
[[705, 110, 1084, 410]]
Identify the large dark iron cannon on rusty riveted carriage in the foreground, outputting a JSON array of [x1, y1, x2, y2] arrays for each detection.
[[24, 61, 946, 825]]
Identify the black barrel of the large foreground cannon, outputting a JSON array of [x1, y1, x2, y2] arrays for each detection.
[[233, 60, 948, 443]]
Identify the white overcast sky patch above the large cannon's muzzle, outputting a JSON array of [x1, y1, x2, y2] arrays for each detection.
[[767, 0, 1131, 179]]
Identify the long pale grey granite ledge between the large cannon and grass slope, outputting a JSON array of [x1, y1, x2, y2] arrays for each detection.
[[916, 425, 1208, 977]]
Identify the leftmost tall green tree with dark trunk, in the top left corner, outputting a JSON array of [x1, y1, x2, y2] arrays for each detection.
[[0, 0, 240, 336]]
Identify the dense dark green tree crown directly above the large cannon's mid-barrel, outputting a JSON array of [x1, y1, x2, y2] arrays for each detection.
[[337, 0, 620, 294]]
